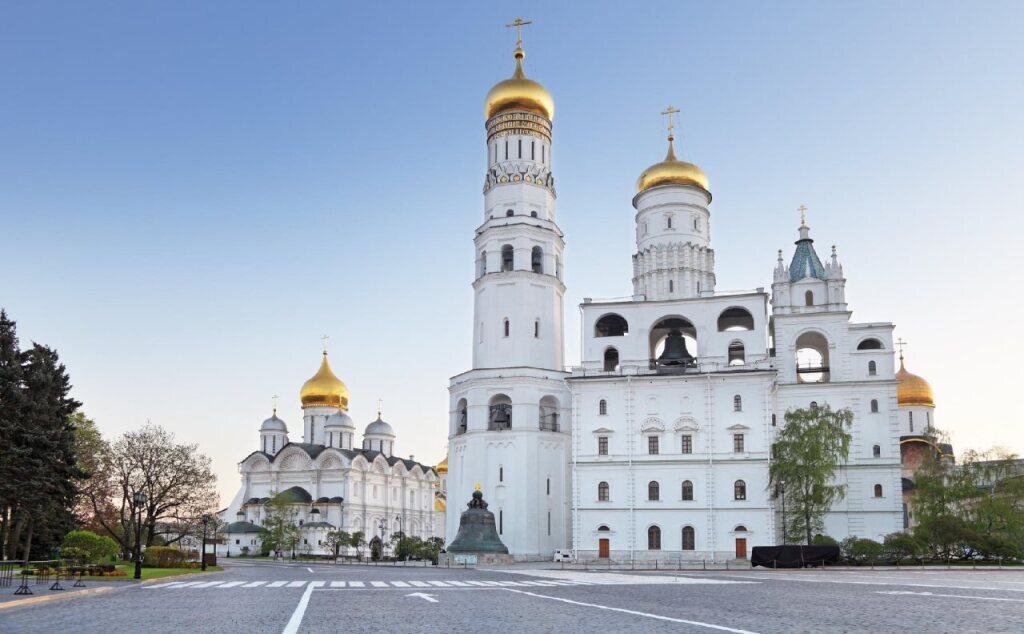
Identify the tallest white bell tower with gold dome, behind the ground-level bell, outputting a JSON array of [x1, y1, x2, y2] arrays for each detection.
[[446, 18, 569, 559]]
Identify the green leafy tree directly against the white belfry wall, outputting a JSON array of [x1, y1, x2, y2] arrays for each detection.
[[768, 405, 853, 544]]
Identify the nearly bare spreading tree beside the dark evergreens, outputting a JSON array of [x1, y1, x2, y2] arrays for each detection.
[[85, 424, 218, 553]]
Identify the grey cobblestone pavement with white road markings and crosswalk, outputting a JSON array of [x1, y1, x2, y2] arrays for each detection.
[[0, 561, 1024, 634]]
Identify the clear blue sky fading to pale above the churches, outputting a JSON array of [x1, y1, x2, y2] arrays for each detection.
[[0, 1, 1024, 501]]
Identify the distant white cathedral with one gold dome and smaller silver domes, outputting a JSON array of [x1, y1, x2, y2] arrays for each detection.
[[219, 350, 446, 556]]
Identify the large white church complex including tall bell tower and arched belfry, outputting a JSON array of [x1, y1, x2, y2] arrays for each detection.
[[446, 32, 931, 560]]
